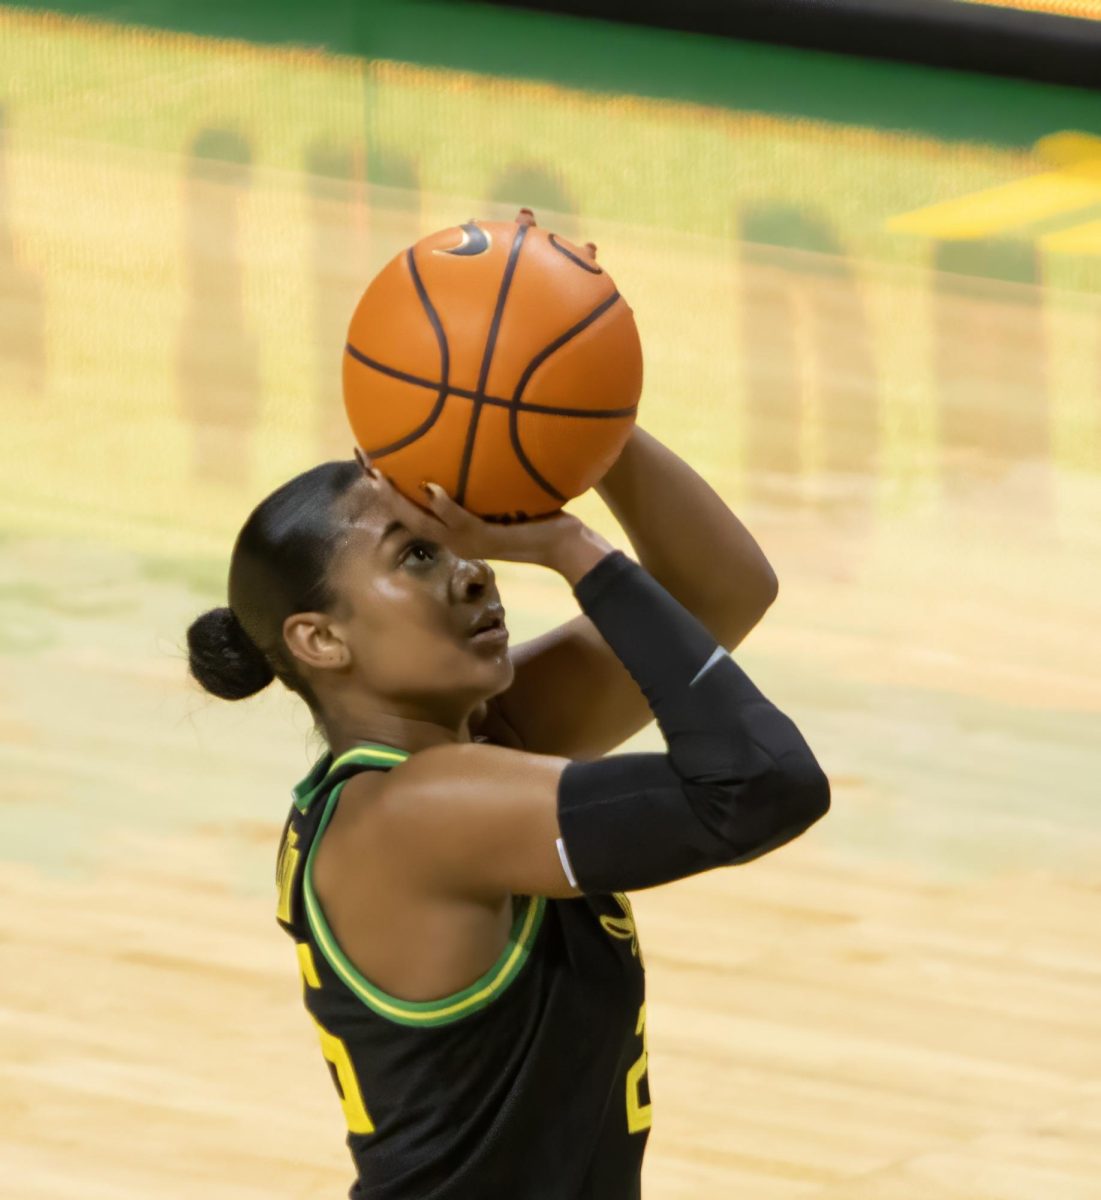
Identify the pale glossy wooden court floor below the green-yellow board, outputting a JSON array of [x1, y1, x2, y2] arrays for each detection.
[[0, 37, 1101, 1200]]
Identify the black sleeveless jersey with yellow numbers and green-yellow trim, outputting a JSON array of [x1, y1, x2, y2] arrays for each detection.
[[276, 742, 651, 1200]]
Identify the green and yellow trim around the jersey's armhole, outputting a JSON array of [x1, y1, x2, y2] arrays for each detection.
[[302, 784, 547, 1028]]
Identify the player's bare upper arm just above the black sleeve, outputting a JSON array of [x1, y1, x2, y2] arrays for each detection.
[[375, 743, 580, 900]]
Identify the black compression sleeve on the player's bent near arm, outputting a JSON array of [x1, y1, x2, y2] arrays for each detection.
[[558, 551, 830, 892]]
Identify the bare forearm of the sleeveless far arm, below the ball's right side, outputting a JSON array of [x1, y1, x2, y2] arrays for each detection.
[[596, 425, 778, 646]]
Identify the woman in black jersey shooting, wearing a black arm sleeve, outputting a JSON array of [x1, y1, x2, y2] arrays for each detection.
[[188, 428, 830, 1200]]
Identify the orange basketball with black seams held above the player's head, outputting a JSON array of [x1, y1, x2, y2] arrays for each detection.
[[344, 209, 642, 522]]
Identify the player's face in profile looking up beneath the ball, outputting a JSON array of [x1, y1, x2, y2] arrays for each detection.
[[330, 475, 513, 721]]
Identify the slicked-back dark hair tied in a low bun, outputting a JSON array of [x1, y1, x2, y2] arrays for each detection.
[[187, 460, 362, 713]]
